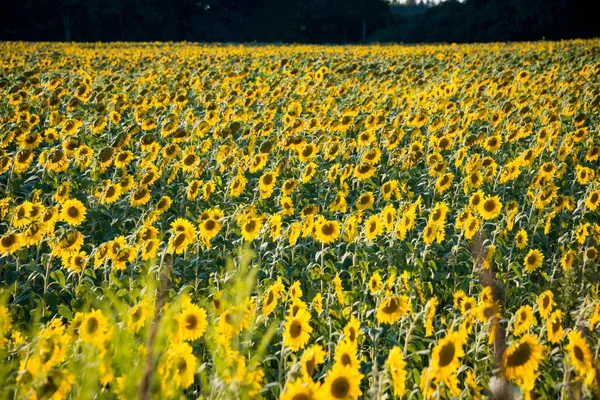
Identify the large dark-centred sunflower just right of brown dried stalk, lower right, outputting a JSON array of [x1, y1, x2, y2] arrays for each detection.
[[502, 334, 543, 382]]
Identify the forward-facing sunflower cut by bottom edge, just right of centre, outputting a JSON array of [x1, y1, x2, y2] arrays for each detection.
[[317, 364, 363, 400]]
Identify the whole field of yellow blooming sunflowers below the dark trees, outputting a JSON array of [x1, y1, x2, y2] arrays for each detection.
[[0, 40, 600, 400]]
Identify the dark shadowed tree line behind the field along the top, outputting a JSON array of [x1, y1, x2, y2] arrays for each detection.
[[0, 0, 600, 43]]
